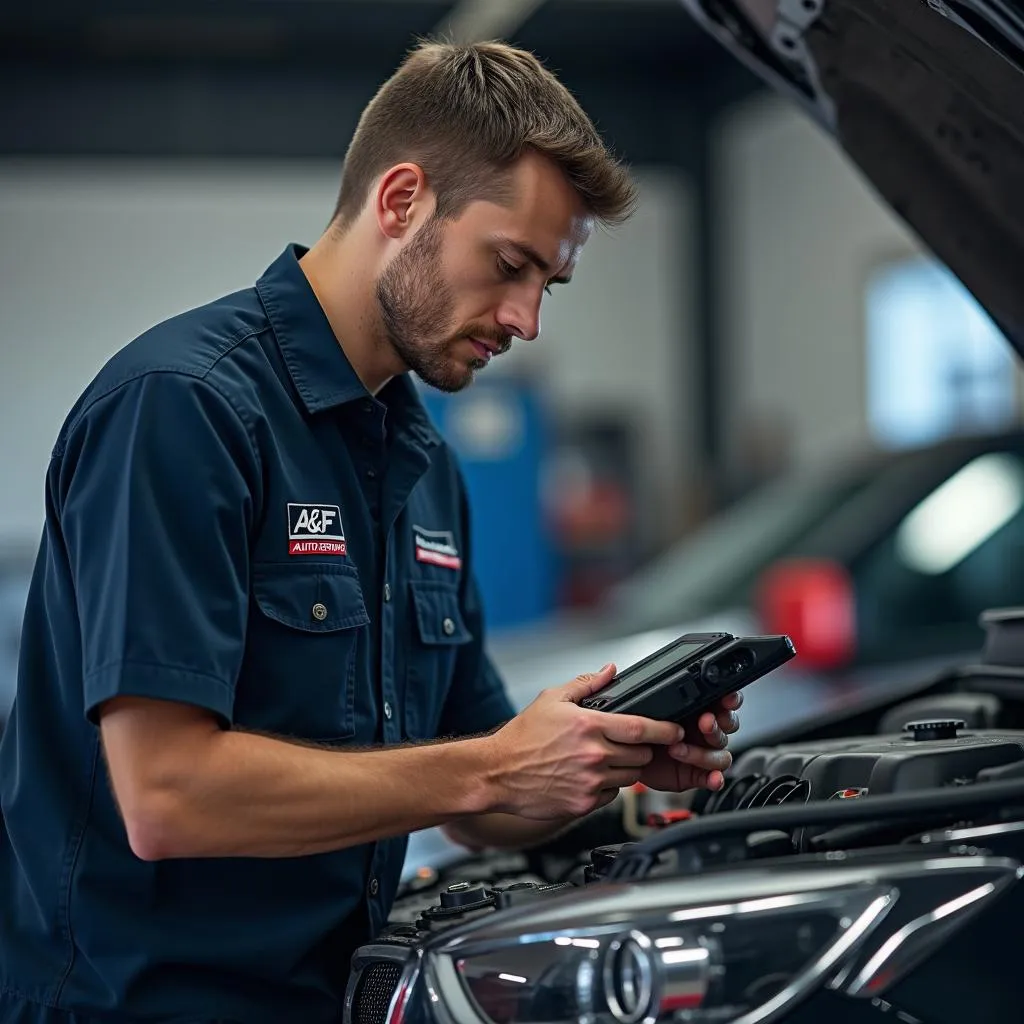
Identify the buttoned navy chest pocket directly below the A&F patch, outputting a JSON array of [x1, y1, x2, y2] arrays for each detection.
[[236, 561, 370, 740]]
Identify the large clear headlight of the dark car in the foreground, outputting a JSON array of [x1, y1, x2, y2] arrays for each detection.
[[449, 888, 893, 1024]]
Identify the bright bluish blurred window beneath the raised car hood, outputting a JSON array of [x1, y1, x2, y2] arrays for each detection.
[[865, 257, 1018, 449]]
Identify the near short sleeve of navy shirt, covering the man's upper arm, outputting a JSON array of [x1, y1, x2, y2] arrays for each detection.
[[51, 372, 260, 723]]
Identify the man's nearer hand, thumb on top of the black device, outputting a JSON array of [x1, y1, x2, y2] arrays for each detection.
[[485, 665, 684, 821]]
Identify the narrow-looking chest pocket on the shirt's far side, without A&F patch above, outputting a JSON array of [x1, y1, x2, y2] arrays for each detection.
[[406, 580, 473, 739]]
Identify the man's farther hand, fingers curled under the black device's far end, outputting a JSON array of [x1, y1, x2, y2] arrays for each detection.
[[639, 693, 743, 793]]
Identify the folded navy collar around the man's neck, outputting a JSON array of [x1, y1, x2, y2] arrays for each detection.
[[256, 243, 440, 445]]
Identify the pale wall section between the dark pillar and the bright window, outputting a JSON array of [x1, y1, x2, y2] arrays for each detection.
[[715, 96, 918, 464]]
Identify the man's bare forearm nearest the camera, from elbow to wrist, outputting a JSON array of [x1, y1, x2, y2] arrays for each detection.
[[126, 731, 501, 859]]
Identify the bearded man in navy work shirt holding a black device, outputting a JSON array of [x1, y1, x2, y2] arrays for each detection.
[[0, 37, 739, 1024]]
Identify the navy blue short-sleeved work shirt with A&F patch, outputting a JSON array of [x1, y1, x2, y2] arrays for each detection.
[[0, 246, 514, 1024]]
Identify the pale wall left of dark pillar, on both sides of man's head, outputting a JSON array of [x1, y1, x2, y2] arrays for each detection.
[[0, 160, 691, 542]]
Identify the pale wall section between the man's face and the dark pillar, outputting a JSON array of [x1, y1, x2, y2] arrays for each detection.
[[508, 170, 699, 537]]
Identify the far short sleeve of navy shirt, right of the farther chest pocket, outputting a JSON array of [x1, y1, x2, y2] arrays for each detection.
[[437, 468, 516, 736]]
